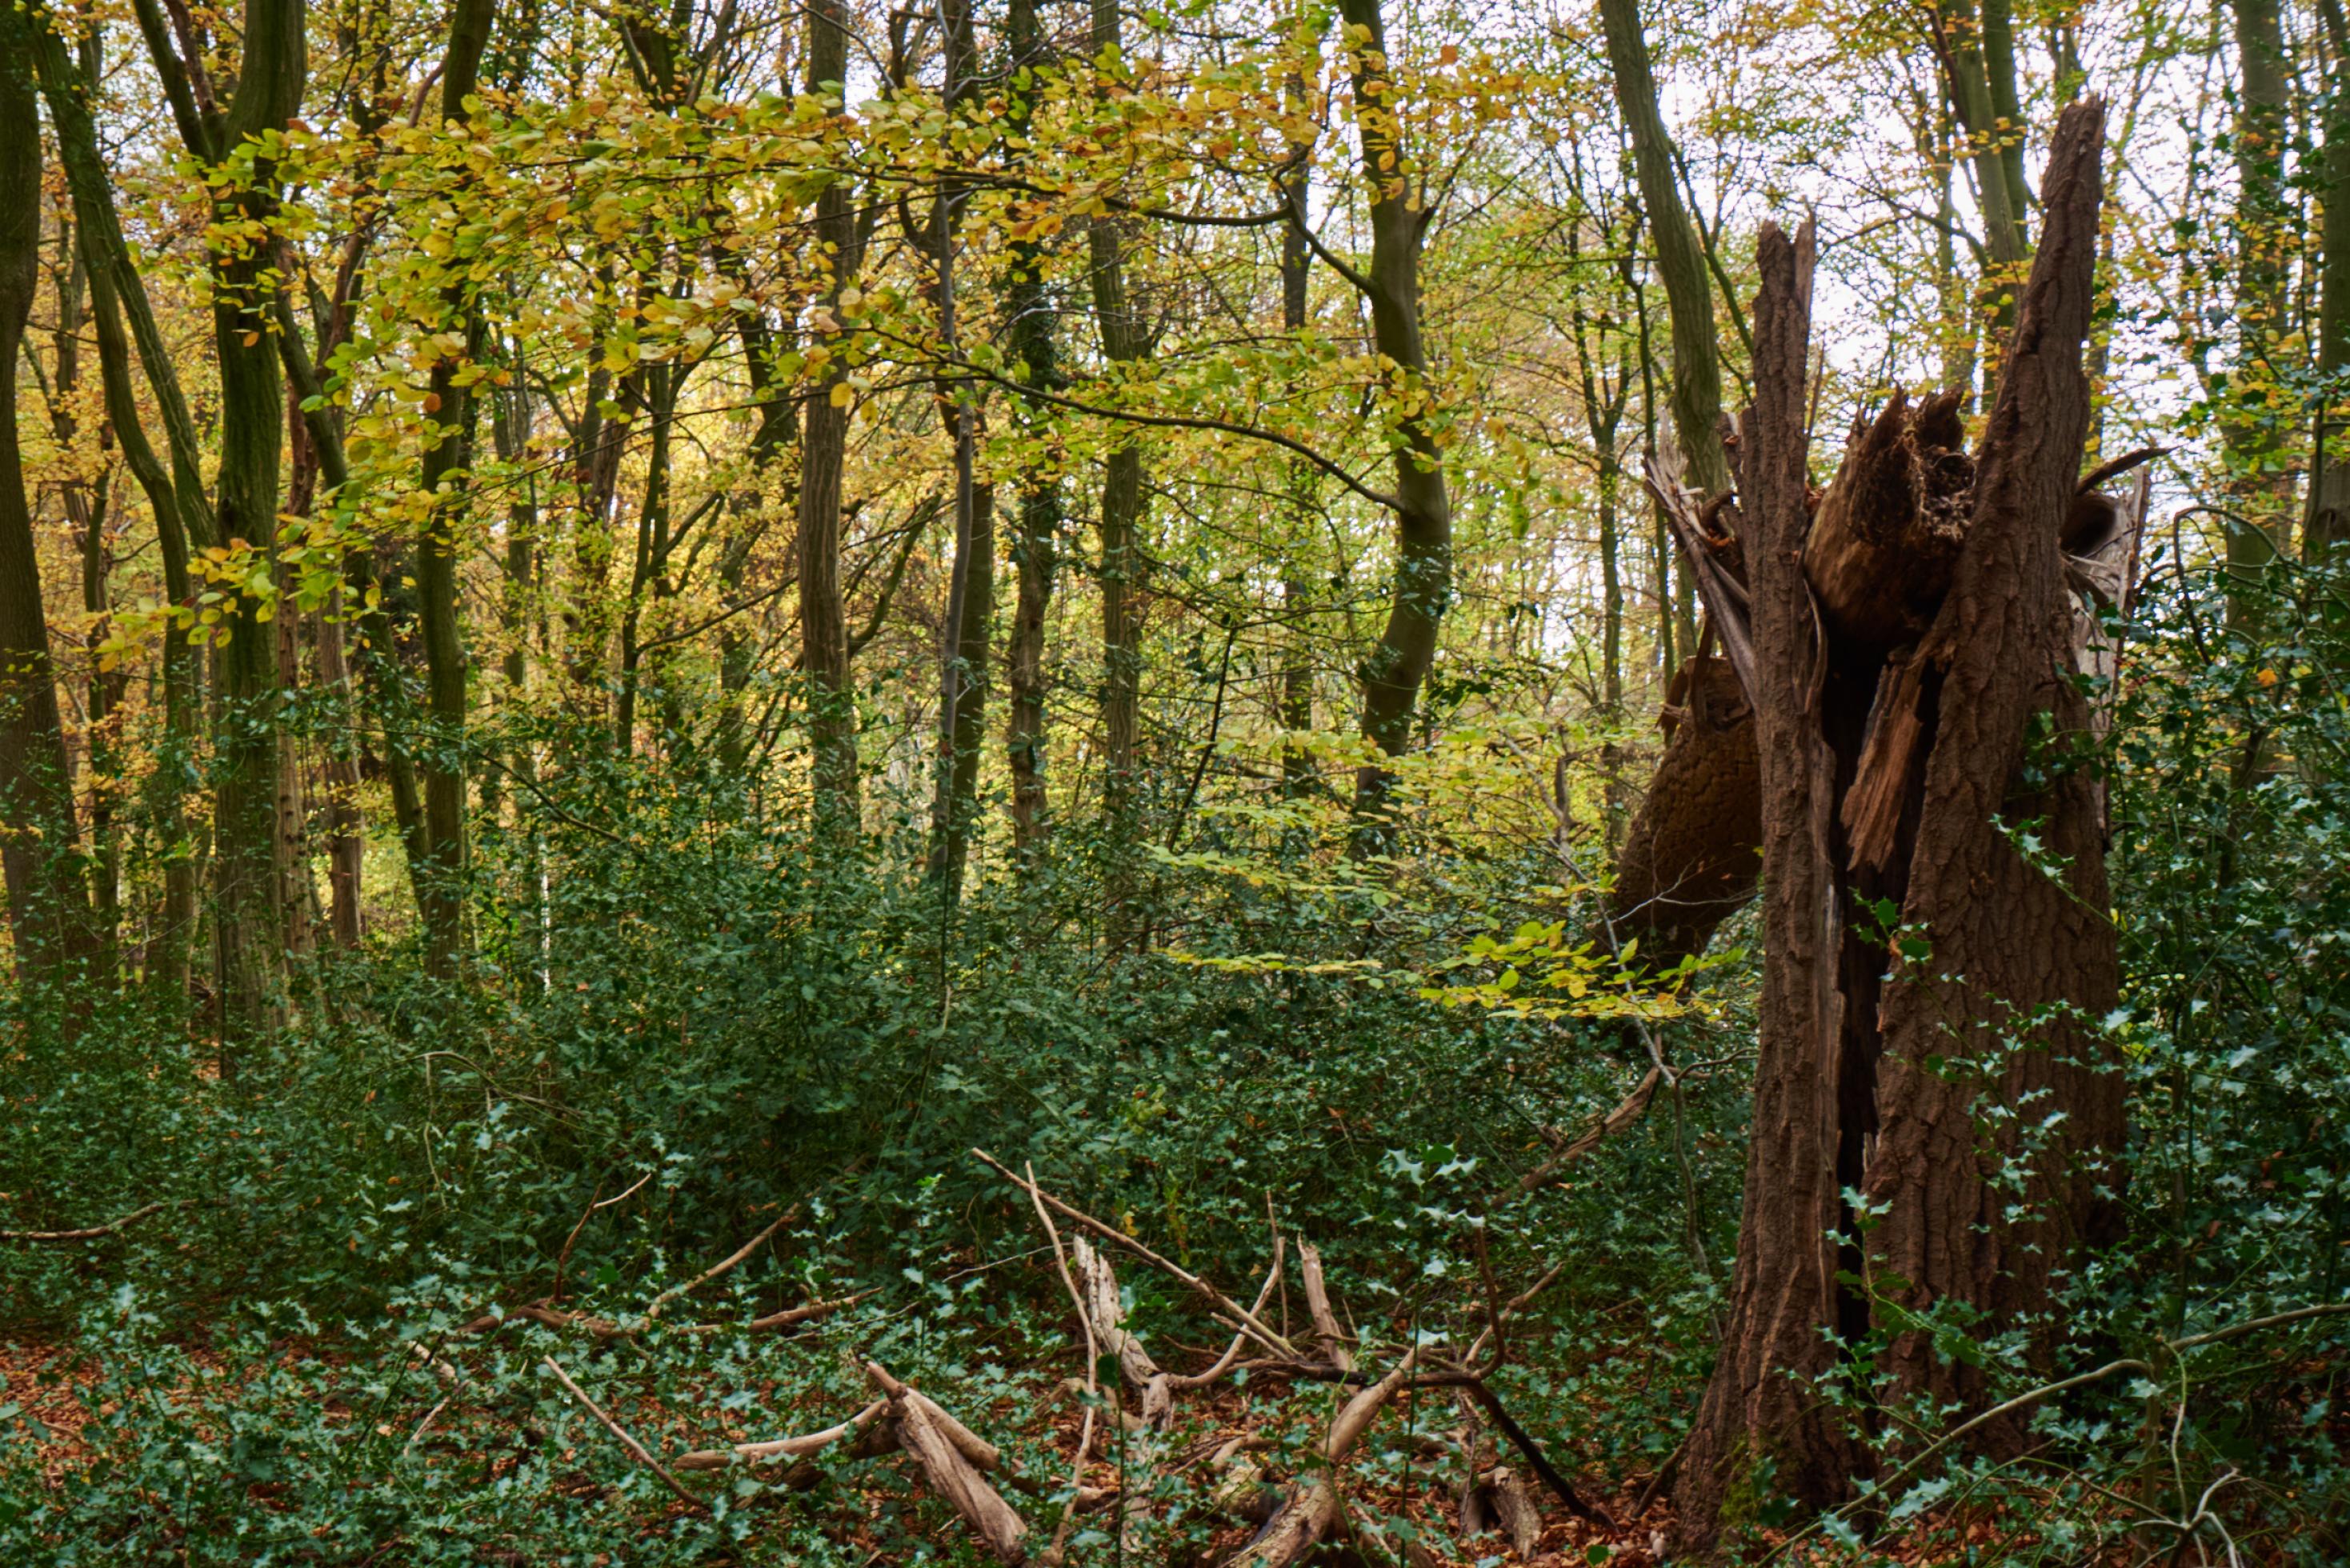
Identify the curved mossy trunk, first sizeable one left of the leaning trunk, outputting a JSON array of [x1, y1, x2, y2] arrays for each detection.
[[1343, 0, 1452, 832]]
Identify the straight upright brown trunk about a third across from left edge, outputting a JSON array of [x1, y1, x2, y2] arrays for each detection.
[[792, 0, 865, 842]]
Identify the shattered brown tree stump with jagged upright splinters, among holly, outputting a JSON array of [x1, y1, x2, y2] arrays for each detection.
[[1678, 101, 2122, 1547]]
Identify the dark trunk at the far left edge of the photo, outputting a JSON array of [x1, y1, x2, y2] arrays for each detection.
[[0, 39, 92, 985]]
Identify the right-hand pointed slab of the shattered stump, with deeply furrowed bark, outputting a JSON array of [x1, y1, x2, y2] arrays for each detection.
[[1864, 101, 2122, 1410]]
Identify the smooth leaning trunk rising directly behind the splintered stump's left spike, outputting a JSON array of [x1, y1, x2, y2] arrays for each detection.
[[1600, 0, 1730, 496]]
